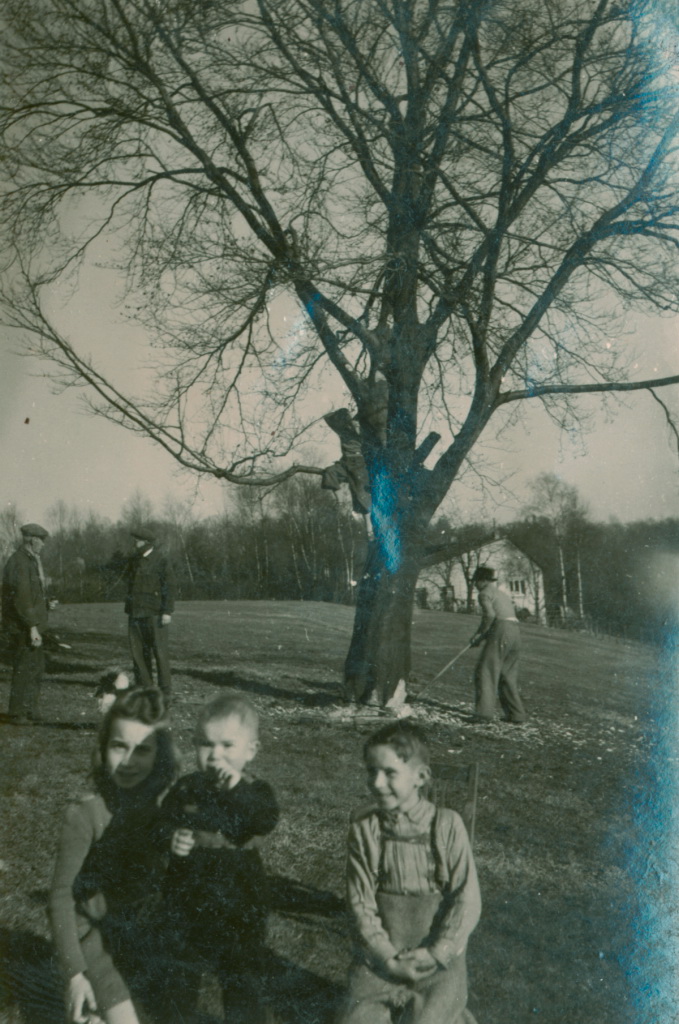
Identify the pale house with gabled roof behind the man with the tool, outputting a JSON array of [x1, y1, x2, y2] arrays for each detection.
[[416, 537, 547, 625]]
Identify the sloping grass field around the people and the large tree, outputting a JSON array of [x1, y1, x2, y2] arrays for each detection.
[[0, 602, 679, 1024]]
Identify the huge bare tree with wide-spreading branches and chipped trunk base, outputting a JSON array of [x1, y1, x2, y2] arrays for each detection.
[[0, 0, 679, 700]]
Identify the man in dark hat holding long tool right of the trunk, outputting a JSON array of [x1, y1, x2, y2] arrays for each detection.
[[470, 565, 525, 724]]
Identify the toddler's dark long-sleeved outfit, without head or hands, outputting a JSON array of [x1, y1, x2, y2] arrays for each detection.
[[161, 771, 279, 1024]]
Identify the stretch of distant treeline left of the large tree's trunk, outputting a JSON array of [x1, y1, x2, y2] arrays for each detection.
[[0, 477, 366, 603]]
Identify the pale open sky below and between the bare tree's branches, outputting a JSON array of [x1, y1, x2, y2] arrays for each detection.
[[0, 290, 679, 523]]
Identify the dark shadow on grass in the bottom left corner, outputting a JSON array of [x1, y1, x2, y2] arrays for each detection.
[[0, 928, 66, 1024]]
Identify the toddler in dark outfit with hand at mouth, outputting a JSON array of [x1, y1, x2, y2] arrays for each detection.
[[162, 694, 279, 1024]]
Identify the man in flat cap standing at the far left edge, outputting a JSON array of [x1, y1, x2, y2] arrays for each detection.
[[2, 522, 50, 723]]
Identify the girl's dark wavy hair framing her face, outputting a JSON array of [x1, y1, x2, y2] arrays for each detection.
[[92, 686, 179, 808]]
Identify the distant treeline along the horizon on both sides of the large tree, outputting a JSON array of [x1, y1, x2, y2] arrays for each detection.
[[0, 485, 679, 640]]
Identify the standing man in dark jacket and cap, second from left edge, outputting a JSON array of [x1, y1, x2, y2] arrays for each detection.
[[125, 526, 174, 700]]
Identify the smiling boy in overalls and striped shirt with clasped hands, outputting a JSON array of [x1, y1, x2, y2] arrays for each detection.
[[339, 722, 480, 1024]]
